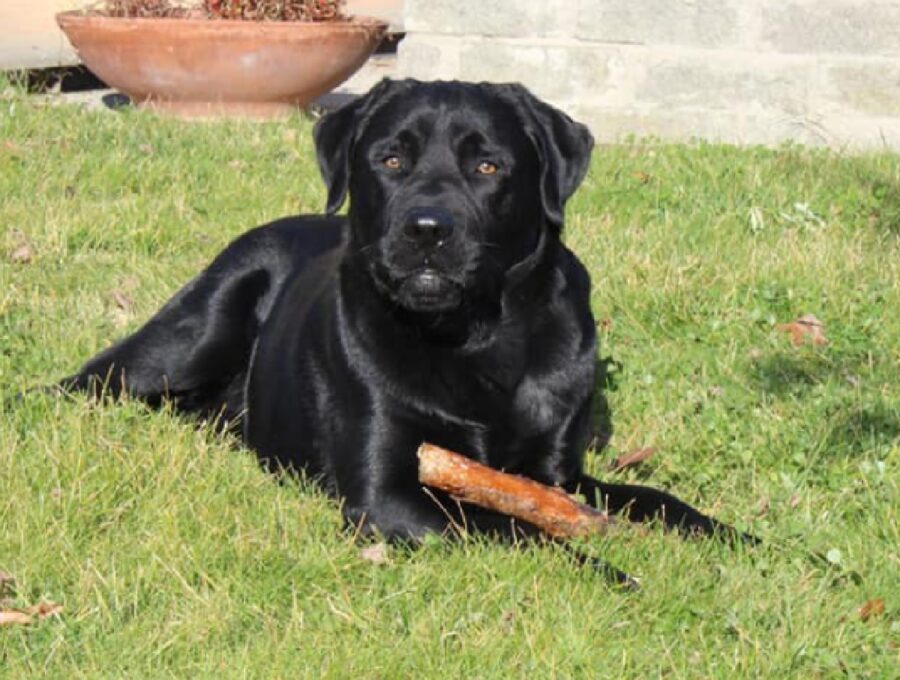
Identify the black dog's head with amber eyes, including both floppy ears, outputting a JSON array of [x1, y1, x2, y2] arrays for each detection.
[[315, 80, 593, 313]]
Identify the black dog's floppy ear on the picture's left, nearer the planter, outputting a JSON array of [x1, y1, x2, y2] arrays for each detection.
[[313, 78, 402, 215]]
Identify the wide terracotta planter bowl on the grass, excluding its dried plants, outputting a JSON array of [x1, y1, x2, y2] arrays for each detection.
[[56, 12, 387, 117]]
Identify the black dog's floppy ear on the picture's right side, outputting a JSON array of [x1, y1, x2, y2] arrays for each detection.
[[508, 85, 594, 228]]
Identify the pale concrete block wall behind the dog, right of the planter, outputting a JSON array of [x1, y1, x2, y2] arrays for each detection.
[[398, 0, 900, 149]]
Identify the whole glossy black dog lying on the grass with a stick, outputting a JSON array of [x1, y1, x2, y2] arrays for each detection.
[[63, 81, 733, 564]]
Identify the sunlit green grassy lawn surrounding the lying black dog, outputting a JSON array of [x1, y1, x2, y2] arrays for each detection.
[[0, 85, 900, 678]]
